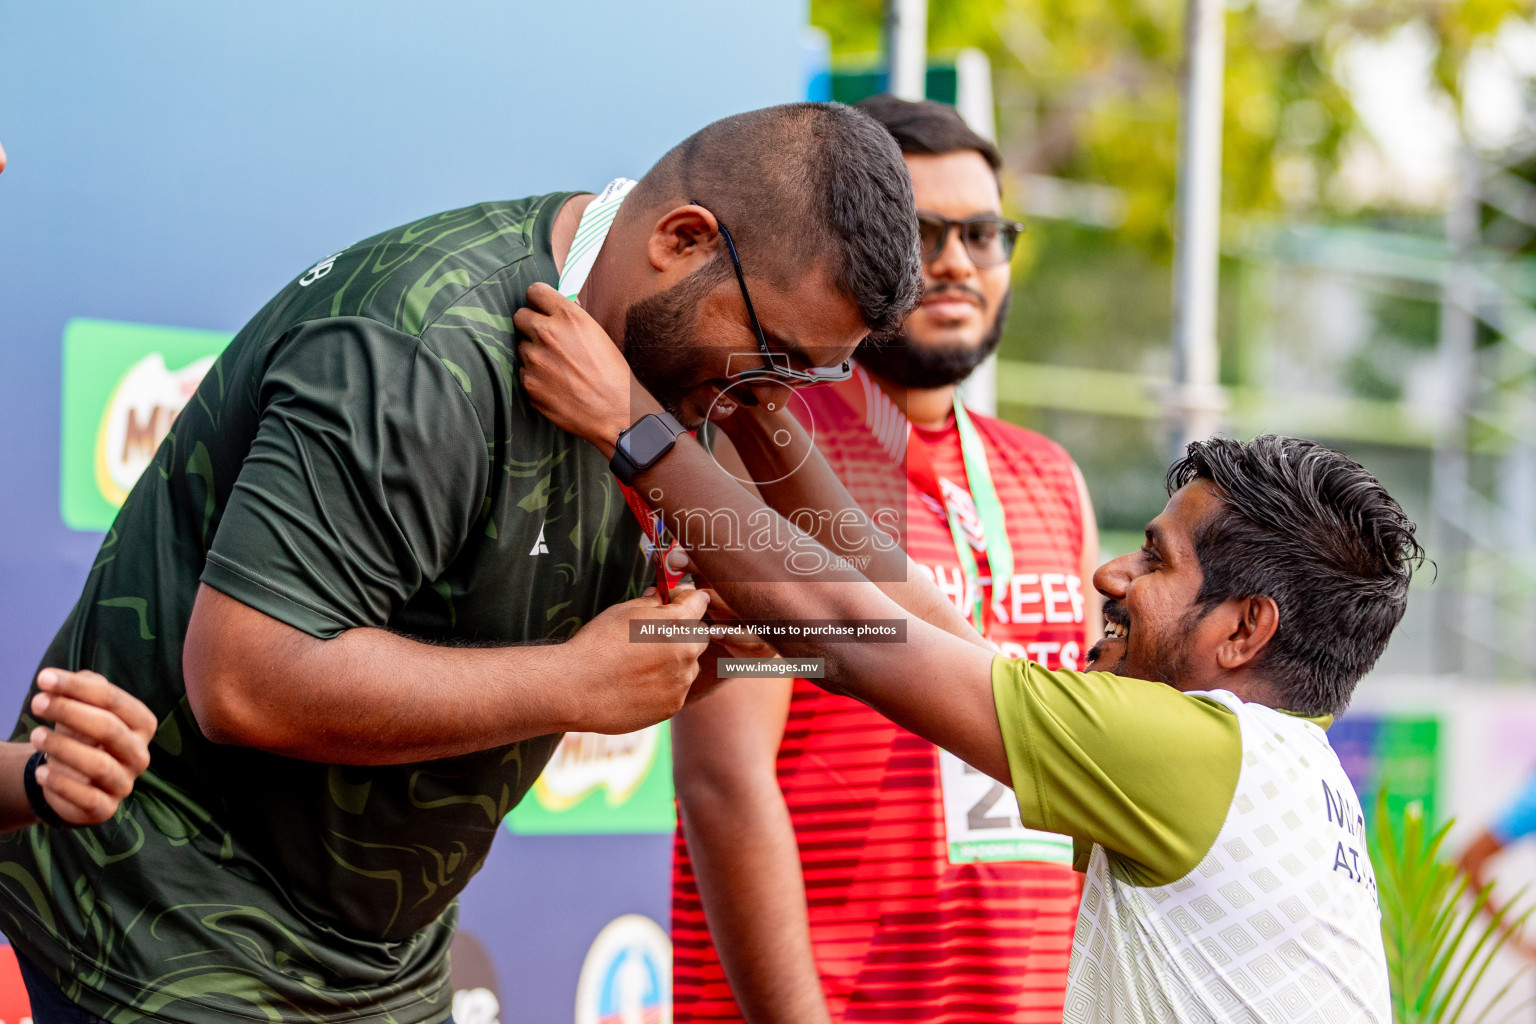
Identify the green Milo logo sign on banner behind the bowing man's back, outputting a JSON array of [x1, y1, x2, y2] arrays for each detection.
[[58, 319, 233, 531]]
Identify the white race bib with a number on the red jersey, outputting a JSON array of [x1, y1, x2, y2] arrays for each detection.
[[938, 751, 1072, 864]]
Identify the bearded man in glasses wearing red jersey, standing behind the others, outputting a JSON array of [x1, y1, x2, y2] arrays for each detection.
[[673, 97, 1100, 1024]]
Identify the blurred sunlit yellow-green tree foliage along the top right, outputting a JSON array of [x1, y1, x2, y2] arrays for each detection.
[[811, 0, 1536, 242]]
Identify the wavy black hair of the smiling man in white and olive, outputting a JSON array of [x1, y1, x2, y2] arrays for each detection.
[[1167, 434, 1424, 715]]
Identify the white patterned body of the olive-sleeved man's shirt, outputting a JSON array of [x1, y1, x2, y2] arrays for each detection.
[[1063, 689, 1392, 1024]]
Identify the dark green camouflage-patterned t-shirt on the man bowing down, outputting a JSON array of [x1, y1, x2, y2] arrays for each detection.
[[0, 193, 644, 1024]]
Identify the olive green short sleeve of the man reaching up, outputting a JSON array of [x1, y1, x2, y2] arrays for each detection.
[[992, 657, 1243, 886]]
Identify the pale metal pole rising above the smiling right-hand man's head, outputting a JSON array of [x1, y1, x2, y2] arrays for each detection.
[[1167, 0, 1226, 453]]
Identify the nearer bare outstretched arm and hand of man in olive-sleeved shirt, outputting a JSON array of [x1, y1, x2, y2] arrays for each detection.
[[515, 286, 1009, 783]]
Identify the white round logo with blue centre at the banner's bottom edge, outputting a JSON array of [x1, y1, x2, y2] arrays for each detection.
[[576, 913, 671, 1024]]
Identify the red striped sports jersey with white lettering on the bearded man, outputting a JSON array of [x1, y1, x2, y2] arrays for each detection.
[[673, 370, 1086, 1024]]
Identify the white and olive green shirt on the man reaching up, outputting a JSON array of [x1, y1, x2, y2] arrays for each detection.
[[992, 659, 1392, 1024]]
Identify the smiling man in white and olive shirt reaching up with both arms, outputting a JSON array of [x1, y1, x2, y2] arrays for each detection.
[[506, 307, 1422, 1024]]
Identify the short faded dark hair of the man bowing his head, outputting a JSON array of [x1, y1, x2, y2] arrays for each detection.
[[633, 103, 923, 336]]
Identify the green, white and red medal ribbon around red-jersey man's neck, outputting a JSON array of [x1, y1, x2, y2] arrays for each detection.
[[833, 368, 1014, 636]]
